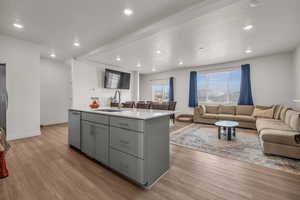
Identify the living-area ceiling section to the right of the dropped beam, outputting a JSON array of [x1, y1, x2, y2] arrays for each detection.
[[83, 0, 300, 73]]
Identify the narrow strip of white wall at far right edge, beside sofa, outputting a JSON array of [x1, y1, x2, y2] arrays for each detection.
[[293, 45, 300, 111]]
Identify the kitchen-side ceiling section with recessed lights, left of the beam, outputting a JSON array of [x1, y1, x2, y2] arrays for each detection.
[[0, 0, 203, 59]]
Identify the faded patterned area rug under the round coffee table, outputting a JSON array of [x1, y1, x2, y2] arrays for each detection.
[[170, 124, 300, 175]]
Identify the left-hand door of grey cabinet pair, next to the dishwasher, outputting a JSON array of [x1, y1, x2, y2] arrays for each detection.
[[81, 121, 95, 158]]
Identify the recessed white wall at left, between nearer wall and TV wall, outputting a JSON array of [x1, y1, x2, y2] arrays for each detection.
[[40, 58, 71, 125]]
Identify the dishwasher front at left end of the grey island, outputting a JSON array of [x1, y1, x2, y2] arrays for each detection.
[[69, 111, 81, 149]]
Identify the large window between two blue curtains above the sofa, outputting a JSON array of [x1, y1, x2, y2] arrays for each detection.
[[197, 69, 241, 104]]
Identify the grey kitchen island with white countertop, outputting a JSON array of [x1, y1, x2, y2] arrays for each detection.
[[69, 107, 174, 188]]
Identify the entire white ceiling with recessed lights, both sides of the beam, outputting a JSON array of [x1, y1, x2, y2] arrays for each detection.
[[0, 0, 300, 73]]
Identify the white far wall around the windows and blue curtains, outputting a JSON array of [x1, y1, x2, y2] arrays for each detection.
[[140, 53, 293, 113]]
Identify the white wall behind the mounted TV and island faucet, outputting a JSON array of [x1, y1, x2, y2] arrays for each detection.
[[71, 60, 134, 107]]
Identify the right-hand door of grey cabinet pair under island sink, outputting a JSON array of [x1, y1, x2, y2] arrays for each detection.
[[93, 124, 109, 165]]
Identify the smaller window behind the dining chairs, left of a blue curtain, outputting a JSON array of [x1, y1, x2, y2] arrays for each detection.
[[152, 80, 169, 102]]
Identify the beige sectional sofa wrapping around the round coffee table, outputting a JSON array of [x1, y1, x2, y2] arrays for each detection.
[[194, 105, 300, 159]]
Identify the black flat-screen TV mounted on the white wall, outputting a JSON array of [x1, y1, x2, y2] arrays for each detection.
[[104, 69, 130, 89]]
